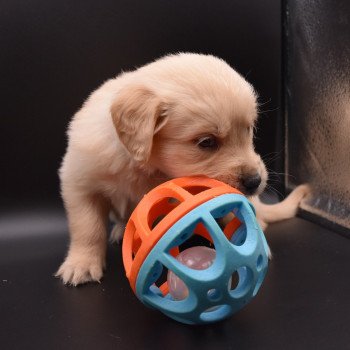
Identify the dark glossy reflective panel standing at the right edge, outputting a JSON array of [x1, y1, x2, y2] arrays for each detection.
[[284, 0, 350, 229]]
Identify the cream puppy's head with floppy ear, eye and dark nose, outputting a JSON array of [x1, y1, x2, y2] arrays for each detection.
[[111, 54, 267, 195]]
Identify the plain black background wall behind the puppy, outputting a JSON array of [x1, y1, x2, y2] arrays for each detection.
[[0, 0, 281, 205]]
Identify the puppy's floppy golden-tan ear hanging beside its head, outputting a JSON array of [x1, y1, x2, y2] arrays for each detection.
[[111, 86, 167, 162]]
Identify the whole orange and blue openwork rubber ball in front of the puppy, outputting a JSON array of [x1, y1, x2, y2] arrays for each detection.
[[122, 177, 268, 324]]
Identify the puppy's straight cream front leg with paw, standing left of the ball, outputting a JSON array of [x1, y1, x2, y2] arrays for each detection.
[[56, 189, 109, 286]]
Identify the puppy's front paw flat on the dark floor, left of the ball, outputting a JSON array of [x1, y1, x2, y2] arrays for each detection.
[[55, 253, 105, 286]]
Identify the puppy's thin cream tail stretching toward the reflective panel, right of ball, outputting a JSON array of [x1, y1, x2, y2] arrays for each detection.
[[251, 185, 310, 230]]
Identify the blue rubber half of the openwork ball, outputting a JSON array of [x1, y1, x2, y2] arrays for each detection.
[[136, 194, 268, 324]]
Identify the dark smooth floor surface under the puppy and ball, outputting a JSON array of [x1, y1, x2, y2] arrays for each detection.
[[0, 207, 350, 350]]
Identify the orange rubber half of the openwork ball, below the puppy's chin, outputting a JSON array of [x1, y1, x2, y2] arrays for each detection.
[[122, 177, 242, 292]]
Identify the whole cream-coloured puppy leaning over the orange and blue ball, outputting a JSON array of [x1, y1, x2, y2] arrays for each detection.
[[57, 54, 305, 285]]
